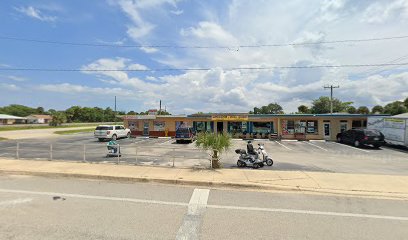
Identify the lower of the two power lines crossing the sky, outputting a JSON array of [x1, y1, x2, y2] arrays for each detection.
[[0, 62, 408, 72]]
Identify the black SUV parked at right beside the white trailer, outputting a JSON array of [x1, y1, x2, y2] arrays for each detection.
[[337, 129, 385, 148]]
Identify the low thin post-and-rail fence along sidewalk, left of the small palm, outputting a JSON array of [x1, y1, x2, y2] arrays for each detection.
[[0, 142, 210, 168]]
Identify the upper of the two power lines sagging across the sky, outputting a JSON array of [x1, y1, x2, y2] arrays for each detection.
[[0, 35, 408, 49]]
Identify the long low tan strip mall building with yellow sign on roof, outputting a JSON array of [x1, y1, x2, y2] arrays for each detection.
[[124, 113, 383, 140]]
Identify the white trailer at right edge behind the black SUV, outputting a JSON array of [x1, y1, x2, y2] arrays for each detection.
[[367, 113, 408, 147]]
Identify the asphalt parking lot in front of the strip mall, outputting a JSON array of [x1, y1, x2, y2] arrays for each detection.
[[0, 134, 408, 175]]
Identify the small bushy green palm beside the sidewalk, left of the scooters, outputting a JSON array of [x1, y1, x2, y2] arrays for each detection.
[[196, 132, 231, 168]]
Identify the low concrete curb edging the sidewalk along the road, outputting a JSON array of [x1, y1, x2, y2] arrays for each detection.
[[0, 170, 408, 200]]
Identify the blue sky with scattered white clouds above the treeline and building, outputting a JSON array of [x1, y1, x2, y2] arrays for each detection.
[[0, 0, 408, 114]]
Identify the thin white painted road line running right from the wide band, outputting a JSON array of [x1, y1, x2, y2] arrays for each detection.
[[207, 205, 408, 221]]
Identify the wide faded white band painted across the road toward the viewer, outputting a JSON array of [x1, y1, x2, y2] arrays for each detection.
[[176, 188, 210, 240]]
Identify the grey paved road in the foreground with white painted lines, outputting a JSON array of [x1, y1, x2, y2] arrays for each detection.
[[0, 175, 408, 240]]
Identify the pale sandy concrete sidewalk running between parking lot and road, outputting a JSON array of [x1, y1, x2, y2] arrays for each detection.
[[0, 158, 408, 200]]
